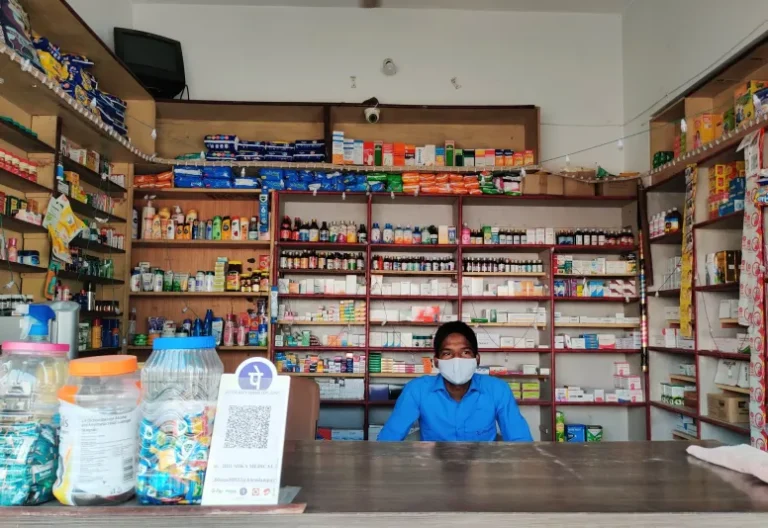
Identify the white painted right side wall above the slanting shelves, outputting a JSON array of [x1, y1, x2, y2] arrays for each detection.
[[622, 0, 768, 171]]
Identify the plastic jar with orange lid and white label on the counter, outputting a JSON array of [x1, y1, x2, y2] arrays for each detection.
[[53, 355, 141, 506]]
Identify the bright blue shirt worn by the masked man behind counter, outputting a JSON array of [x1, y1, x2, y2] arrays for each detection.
[[379, 374, 533, 442]]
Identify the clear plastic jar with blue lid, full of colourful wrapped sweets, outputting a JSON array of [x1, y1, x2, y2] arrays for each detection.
[[136, 337, 224, 504]]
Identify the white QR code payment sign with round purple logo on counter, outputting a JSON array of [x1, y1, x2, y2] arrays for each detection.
[[202, 358, 291, 506]]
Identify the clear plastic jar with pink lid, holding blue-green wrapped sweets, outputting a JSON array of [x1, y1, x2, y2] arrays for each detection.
[[0, 341, 69, 506]]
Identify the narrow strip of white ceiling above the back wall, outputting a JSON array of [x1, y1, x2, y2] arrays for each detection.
[[133, 0, 634, 14]]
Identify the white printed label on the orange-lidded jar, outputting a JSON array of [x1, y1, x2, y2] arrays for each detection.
[[54, 401, 140, 505]]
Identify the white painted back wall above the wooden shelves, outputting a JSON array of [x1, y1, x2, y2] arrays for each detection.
[[127, 4, 623, 170]]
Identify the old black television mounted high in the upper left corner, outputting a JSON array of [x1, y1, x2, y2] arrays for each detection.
[[115, 28, 186, 99]]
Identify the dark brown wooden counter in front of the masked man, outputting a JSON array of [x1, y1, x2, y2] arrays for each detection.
[[6, 442, 768, 528]]
